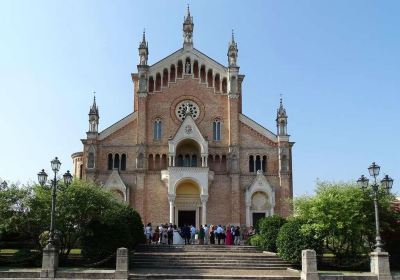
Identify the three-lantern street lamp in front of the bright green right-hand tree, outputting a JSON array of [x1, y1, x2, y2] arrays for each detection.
[[357, 162, 393, 252]]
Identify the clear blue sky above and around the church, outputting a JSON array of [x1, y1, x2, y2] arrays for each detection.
[[0, 0, 400, 194]]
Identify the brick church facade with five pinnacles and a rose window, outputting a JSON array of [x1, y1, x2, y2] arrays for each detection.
[[72, 9, 293, 226]]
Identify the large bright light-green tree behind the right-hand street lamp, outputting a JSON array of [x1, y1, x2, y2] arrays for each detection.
[[294, 182, 394, 261]]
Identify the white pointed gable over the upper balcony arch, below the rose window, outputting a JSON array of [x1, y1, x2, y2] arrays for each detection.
[[168, 115, 208, 155]]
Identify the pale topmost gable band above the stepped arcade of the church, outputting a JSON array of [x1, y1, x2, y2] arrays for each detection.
[[149, 48, 227, 75]]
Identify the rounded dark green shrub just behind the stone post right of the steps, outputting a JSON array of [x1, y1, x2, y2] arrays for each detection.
[[276, 218, 322, 263]]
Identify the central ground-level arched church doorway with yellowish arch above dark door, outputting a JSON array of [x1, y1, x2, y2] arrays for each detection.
[[175, 179, 201, 227]]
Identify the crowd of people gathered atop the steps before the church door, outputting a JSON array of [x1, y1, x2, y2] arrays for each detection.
[[144, 223, 255, 245]]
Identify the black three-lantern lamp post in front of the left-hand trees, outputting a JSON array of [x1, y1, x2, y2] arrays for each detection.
[[38, 157, 72, 245]]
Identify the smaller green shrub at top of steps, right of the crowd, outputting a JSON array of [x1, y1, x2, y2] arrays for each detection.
[[258, 215, 286, 252]]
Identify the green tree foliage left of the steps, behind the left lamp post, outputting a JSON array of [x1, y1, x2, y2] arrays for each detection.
[[0, 180, 143, 262]]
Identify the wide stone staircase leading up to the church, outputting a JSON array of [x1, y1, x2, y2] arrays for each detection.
[[130, 245, 299, 280]]
